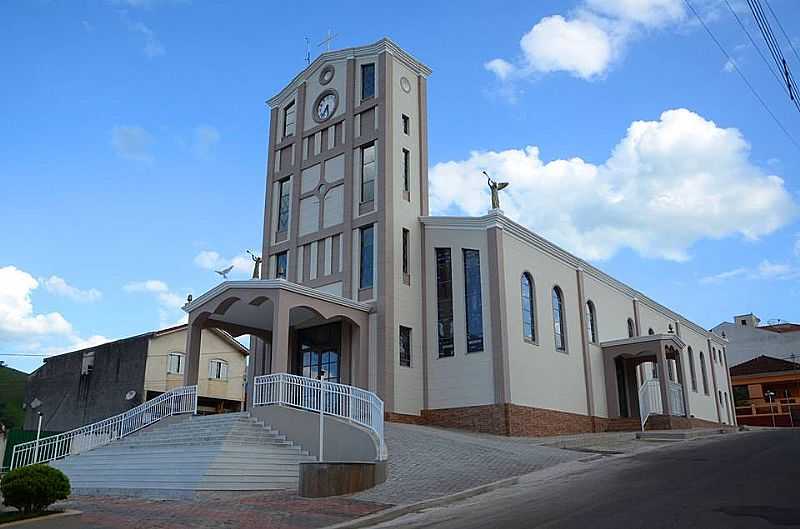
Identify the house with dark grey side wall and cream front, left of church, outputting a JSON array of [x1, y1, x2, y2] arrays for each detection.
[[25, 325, 247, 431]]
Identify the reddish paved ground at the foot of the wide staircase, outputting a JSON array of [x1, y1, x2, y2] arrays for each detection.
[[20, 492, 386, 529]]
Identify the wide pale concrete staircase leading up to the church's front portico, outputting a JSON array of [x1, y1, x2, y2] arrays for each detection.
[[51, 413, 315, 494]]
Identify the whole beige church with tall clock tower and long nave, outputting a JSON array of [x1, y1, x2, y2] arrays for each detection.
[[184, 39, 735, 435]]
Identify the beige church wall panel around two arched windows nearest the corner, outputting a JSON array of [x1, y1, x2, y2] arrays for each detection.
[[503, 232, 588, 414]]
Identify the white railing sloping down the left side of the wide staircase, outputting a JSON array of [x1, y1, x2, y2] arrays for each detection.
[[11, 386, 197, 469]]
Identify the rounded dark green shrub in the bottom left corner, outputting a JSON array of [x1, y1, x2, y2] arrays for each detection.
[[0, 465, 70, 513]]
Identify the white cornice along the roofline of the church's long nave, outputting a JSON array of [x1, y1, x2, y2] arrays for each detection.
[[420, 210, 727, 345]]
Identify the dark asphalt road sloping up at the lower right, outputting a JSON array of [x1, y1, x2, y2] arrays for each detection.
[[378, 429, 800, 529]]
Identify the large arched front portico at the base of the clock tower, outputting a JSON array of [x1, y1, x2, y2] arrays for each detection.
[[184, 279, 372, 402]]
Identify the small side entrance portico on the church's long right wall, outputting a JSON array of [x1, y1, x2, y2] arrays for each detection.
[[600, 334, 691, 427]]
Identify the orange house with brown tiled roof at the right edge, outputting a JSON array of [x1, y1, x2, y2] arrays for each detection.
[[731, 355, 800, 426]]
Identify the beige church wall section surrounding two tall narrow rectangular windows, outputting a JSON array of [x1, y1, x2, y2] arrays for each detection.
[[425, 226, 494, 409]]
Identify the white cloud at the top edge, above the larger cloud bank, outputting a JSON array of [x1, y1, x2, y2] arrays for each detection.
[[484, 0, 686, 81]]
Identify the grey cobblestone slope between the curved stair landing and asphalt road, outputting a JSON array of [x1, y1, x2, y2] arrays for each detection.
[[352, 423, 587, 505]]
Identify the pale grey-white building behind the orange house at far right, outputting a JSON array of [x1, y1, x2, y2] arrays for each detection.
[[712, 314, 800, 365]]
